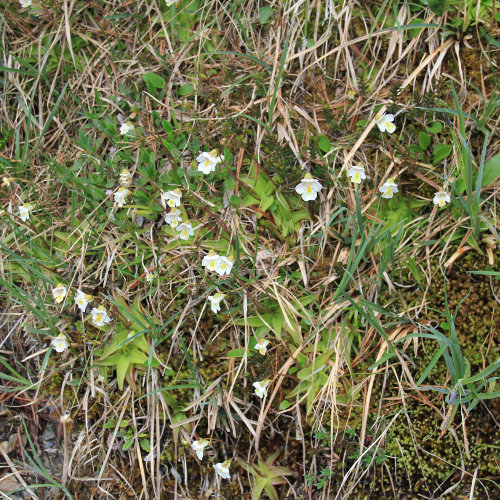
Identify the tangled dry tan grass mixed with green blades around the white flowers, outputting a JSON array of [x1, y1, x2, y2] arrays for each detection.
[[0, 0, 499, 499]]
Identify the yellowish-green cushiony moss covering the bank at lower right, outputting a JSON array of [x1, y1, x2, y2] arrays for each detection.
[[344, 245, 500, 498]]
